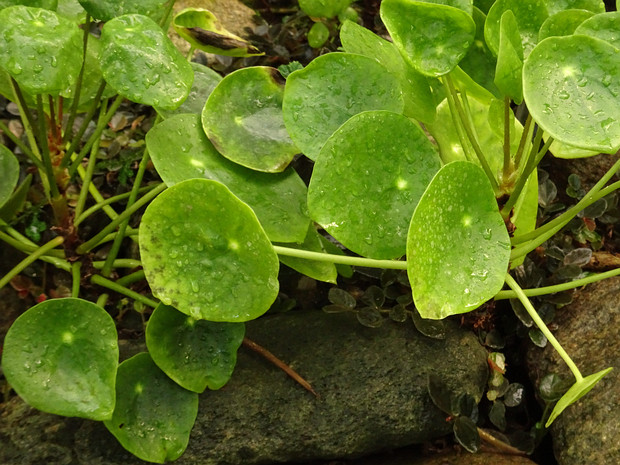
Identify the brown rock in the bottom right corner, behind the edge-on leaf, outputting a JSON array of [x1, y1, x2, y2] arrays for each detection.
[[528, 277, 620, 465]]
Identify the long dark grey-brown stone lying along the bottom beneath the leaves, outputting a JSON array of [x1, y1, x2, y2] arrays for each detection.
[[0, 311, 487, 465]]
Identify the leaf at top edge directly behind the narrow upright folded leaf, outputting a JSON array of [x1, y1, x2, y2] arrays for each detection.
[[484, 0, 549, 57]]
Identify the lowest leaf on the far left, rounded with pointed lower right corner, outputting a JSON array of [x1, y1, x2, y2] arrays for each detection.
[[2, 298, 118, 420]]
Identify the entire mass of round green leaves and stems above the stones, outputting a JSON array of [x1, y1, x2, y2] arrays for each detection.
[[0, 0, 620, 462]]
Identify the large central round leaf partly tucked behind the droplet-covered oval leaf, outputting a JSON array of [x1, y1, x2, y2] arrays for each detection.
[[308, 111, 441, 259]]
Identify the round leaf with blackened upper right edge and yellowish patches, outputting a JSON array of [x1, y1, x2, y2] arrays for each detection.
[[202, 66, 299, 173]]
